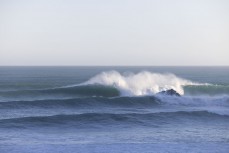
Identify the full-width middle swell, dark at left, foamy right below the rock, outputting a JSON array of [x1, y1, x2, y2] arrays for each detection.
[[0, 95, 229, 109]]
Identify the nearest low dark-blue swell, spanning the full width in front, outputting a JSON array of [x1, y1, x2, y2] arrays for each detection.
[[0, 111, 229, 128]]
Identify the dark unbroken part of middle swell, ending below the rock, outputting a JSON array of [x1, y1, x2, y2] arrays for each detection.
[[0, 96, 161, 109]]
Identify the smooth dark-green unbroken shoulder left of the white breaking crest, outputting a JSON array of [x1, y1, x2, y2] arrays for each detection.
[[0, 85, 120, 102]]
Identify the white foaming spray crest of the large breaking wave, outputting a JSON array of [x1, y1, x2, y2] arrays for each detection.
[[81, 71, 202, 96]]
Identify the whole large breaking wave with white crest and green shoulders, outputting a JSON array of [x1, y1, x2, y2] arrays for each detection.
[[0, 71, 225, 102]]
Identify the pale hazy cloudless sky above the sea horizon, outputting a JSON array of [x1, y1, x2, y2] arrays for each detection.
[[0, 0, 229, 65]]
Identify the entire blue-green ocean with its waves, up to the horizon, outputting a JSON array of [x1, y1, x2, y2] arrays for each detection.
[[0, 66, 229, 153]]
